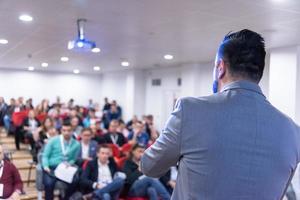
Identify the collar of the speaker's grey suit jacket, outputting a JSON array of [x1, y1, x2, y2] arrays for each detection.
[[221, 80, 265, 97]]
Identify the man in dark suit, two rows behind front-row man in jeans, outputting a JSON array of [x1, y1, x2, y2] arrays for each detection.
[[104, 120, 127, 147]]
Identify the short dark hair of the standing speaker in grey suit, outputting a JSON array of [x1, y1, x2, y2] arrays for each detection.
[[218, 29, 266, 83]]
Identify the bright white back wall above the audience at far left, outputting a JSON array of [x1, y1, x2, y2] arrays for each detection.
[[0, 70, 101, 105]]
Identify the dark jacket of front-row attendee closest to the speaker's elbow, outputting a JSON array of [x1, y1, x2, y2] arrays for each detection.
[[123, 160, 143, 186]]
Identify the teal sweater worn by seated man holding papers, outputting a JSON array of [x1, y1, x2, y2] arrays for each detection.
[[42, 135, 80, 168]]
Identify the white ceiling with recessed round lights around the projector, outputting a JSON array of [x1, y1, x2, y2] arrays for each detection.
[[0, 0, 300, 73]]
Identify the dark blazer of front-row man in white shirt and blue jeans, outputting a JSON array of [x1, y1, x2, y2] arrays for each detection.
[[80, 158, 118, 193]]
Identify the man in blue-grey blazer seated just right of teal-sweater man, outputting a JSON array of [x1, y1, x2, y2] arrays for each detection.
[[76, 128, 98, 166]]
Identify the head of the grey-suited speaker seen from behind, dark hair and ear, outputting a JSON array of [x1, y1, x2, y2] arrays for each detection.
[[214, 29, 266, 90]]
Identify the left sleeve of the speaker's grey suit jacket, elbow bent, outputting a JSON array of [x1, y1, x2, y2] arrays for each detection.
[[141, 97, 183, 178]]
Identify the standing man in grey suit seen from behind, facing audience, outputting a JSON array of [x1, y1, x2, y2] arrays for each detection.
[[140, 30, 300, 200]]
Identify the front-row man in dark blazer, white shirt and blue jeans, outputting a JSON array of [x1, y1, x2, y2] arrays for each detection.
[[80, 144, 125, 200]]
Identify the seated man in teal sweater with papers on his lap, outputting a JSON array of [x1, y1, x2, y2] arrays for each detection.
[[42, 119, 80, 200]]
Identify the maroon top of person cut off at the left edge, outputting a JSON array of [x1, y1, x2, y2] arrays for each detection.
[[0, 160, 23, 199]]
